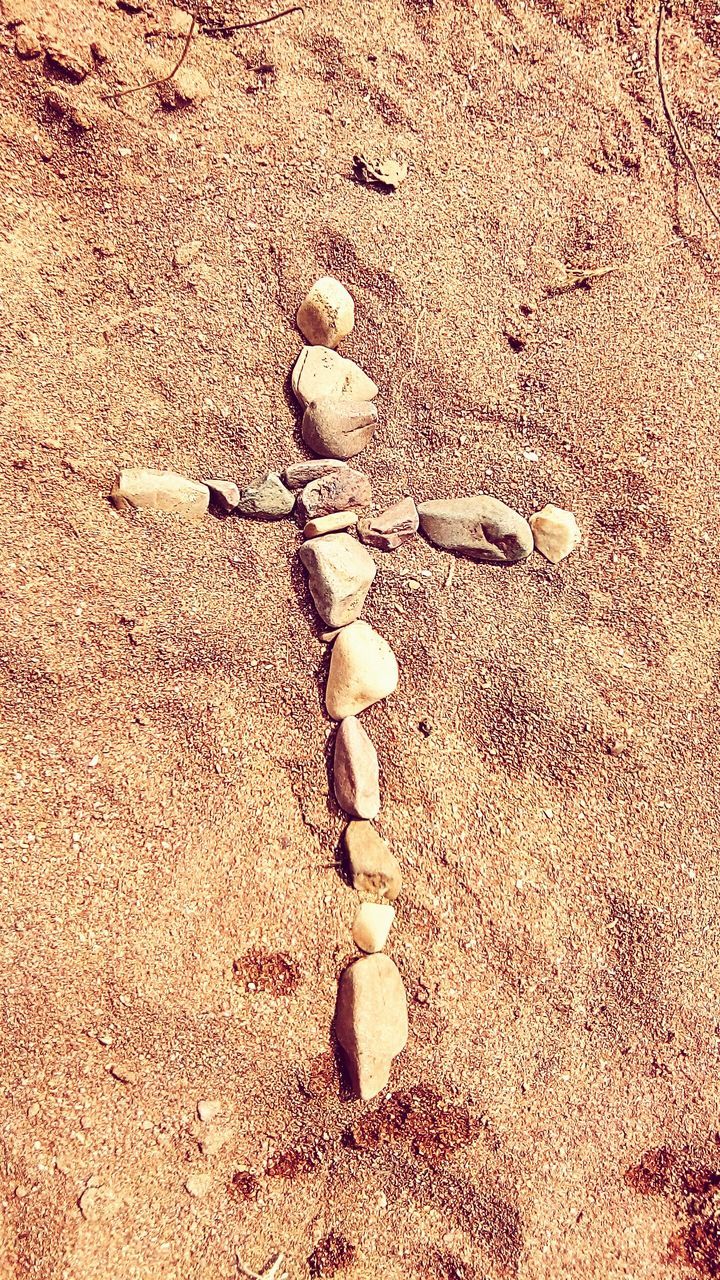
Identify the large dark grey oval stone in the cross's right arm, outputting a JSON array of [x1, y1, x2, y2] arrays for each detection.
[[418, 493, 533, 564]]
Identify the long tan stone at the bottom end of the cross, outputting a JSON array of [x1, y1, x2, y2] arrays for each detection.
[[334, 955, 407, 1100]]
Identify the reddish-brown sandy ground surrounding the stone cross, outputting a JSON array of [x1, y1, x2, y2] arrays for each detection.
[[0, 0, 720, 1280]]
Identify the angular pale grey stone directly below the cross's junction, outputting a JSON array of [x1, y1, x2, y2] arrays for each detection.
[[299, 534, 377, 627]]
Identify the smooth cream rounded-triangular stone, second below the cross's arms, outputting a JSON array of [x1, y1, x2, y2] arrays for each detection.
[[325, 622, 398, 719]]
